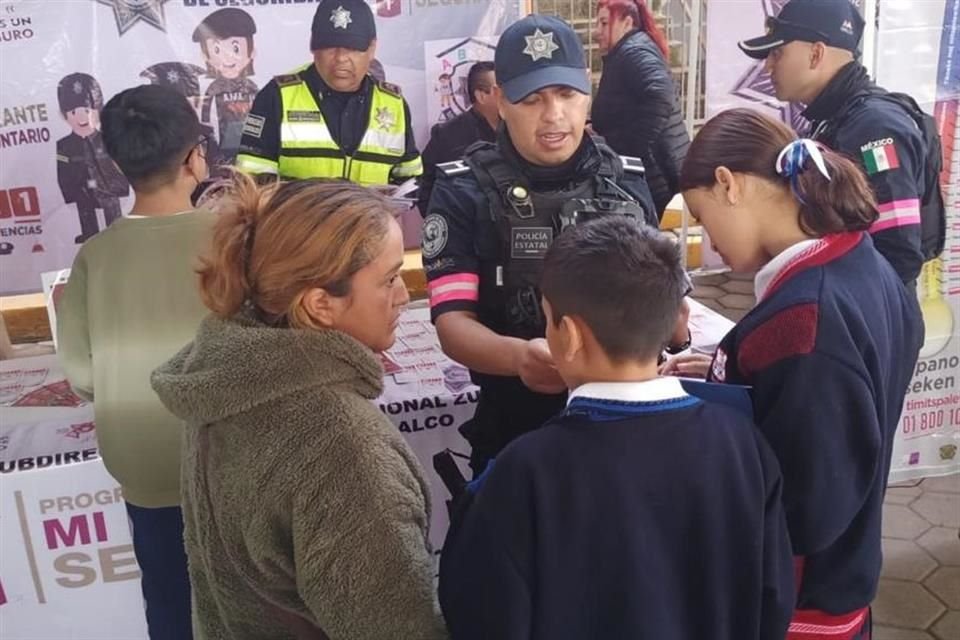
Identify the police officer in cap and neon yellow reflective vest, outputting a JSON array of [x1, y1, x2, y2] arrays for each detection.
[[237, 0, 422, 184]]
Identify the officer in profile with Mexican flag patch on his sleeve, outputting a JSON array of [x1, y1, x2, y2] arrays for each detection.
[[739, 0, 943, 287]]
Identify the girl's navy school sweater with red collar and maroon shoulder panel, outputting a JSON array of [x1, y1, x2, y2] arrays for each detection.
[[710, 233, 923, 640]]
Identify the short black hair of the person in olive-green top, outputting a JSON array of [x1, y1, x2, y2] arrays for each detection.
[[100, 85, 202, 191]]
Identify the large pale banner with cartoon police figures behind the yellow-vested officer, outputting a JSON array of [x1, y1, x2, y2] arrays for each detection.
[[0, 0, 520, 294]]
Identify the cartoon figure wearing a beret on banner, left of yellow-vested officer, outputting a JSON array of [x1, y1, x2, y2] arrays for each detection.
[[193, 9, 257, 162]]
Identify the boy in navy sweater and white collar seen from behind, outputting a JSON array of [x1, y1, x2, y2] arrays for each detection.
[[440, 216, 793, 640]]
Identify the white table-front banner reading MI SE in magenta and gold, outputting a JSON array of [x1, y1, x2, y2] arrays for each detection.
[[0, 460, 147, 640]]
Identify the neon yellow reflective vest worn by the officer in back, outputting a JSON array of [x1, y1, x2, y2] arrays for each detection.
[[278, 76, 412, 184]]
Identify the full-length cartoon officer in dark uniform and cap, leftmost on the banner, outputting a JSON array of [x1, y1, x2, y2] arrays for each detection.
[[57, 73, 130, 244]]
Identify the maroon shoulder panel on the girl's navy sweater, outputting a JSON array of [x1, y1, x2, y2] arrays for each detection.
[[737, 302, 820, 376]]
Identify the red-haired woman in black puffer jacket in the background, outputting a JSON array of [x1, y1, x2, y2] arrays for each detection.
[[591, 0, 690, 217]]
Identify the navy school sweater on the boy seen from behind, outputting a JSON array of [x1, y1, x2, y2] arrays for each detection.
[[440, 379, 793, 640]]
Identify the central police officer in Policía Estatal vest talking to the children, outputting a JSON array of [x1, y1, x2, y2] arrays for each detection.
[[422, 15, 688, 475]]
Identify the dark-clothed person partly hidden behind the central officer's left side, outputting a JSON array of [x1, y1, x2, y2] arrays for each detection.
[[417, 60, 500, 216]]
